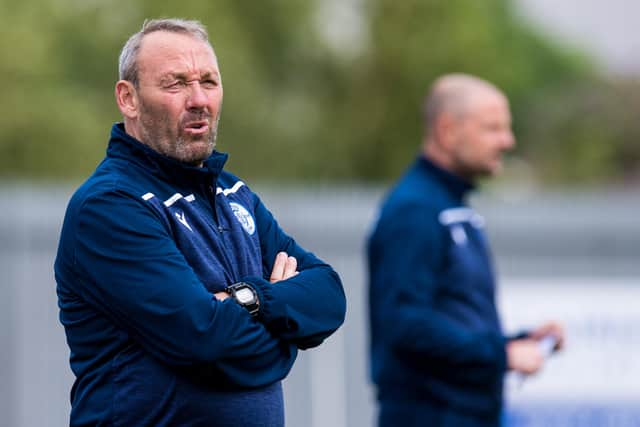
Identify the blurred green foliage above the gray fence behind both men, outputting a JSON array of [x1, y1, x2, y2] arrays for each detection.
[[0, 0, 640, 183]]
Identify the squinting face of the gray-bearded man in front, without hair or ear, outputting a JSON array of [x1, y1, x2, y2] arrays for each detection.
[[132, 31, 222, 165]]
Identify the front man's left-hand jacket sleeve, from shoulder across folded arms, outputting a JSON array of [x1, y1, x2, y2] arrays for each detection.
[[74, 191, 296, 386]]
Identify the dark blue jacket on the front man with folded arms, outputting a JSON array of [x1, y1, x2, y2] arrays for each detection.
[[55, 124, 345, 426]]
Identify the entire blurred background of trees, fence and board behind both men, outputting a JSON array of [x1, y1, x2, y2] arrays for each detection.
[[0, 0, 640, 427]]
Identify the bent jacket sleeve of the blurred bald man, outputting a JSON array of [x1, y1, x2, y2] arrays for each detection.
[[368, 202, 506, 382]]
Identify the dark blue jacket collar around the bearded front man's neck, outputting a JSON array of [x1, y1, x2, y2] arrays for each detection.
[[107, 123, 229, 186]]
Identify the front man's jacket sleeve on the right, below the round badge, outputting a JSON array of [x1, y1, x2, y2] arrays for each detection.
[[245, 196, 346, 349]]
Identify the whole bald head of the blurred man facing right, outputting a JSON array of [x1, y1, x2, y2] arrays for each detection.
[[423, 74, 515, 181]]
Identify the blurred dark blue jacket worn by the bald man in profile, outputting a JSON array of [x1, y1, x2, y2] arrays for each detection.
[[368, 157, 506, 426]]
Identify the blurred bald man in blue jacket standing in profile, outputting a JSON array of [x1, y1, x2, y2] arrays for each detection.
[[368, 74, 563, 427]]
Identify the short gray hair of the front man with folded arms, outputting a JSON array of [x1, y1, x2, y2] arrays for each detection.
[[118, 19, 213, 87]]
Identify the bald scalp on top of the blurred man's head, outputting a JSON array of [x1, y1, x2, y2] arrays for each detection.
[[424, 73, 504, 134]]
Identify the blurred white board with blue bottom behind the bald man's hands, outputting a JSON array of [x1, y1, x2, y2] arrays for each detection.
[[500, 277, 640, 427]]
